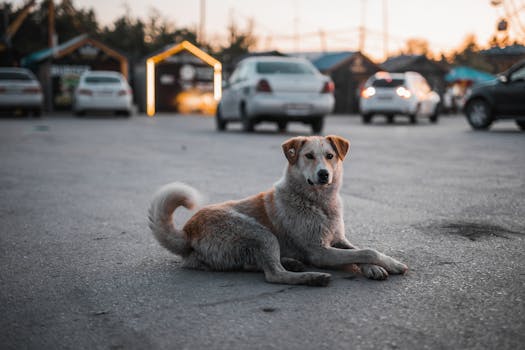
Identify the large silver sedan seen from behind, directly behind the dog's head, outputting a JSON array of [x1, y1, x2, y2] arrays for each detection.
[[216, 56, 334, 133]]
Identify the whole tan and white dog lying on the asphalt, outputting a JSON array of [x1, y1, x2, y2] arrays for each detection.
[[149, 135, 408, 286]]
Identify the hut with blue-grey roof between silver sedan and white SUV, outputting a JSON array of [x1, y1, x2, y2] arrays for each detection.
[[312, 51, 380, 114]]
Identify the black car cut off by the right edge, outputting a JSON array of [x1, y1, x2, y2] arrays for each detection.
[[464, 60, 525, 130]]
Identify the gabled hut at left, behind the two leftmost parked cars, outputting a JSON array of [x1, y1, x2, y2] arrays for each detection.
[[21, 35, 129, 111]]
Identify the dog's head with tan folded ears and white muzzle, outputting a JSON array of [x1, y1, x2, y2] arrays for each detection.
[[282, 135, 350, 186]]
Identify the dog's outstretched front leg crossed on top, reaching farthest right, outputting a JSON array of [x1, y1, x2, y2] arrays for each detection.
[[308, 247, 408, 274]]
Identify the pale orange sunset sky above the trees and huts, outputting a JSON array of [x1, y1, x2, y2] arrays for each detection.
[[15, 0, 525, 59]]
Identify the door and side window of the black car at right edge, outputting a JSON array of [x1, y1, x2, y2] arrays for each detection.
[[494, 64, 525, 115]]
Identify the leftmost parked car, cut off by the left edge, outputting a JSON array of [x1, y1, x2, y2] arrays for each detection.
[[0, 67, 44, 116]]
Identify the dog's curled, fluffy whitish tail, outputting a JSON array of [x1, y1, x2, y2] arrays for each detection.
[[148, 182, 200, 256]]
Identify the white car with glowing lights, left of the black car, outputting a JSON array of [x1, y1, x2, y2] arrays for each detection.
[[359, 72, 440, 124]]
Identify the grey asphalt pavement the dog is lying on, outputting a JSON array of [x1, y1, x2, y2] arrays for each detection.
[[0, 114, 525, 349]]
